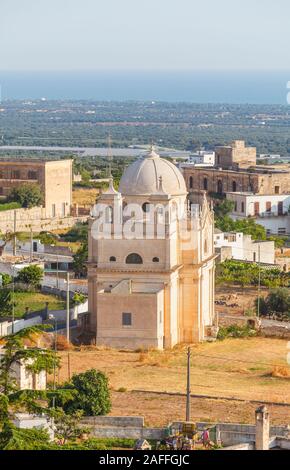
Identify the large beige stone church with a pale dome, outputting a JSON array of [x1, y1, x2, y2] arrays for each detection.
[[88, 147, 216, 350]]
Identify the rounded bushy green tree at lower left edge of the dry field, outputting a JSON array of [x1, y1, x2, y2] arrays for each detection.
[[52, 369, 111, 416]]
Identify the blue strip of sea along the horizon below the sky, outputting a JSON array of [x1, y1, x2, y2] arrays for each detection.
[[0, 70, 290, 105]]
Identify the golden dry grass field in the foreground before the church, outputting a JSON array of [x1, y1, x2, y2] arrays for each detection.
[[53, 337, 290, 425]]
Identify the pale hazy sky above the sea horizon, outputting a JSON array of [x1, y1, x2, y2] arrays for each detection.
[[0, 0, 290, 70]]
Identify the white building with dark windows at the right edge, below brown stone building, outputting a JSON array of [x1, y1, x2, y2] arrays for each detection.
[[227, 193, 290, 235]]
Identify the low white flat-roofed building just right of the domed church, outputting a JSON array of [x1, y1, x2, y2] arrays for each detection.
[[214, 229, 275, 264]]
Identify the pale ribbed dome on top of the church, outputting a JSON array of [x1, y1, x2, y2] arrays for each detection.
[[119, 148, 187, 196]]
